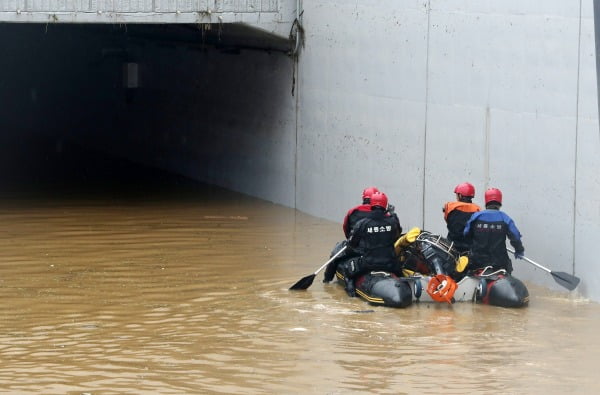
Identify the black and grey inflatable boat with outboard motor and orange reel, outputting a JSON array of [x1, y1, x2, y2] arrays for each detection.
[[332, 228, 529, 308]]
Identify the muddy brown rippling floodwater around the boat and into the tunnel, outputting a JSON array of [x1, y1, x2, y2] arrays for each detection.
[[0, 160, 600, 394]]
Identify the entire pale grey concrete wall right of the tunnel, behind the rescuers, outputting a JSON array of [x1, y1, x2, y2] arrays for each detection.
[[297, 0, 600, 300]]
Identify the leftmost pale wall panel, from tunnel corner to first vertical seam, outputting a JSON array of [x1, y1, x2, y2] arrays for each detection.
[[297, 1, 428, 229]]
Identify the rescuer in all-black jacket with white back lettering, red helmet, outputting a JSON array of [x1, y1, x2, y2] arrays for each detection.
[[344, 192, 402, 297]]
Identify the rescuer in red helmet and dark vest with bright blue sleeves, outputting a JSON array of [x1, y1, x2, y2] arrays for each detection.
[[463, 188, 525, 274]]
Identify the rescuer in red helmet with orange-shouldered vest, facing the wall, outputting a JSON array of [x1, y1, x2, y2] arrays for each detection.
[[442, 182, 481, 253]]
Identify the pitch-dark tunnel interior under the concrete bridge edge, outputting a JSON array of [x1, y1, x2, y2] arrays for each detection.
[[0, 24, 290, 199]]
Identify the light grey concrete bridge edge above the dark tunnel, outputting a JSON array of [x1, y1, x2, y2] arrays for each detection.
[[0, 0, 297, 37]]
